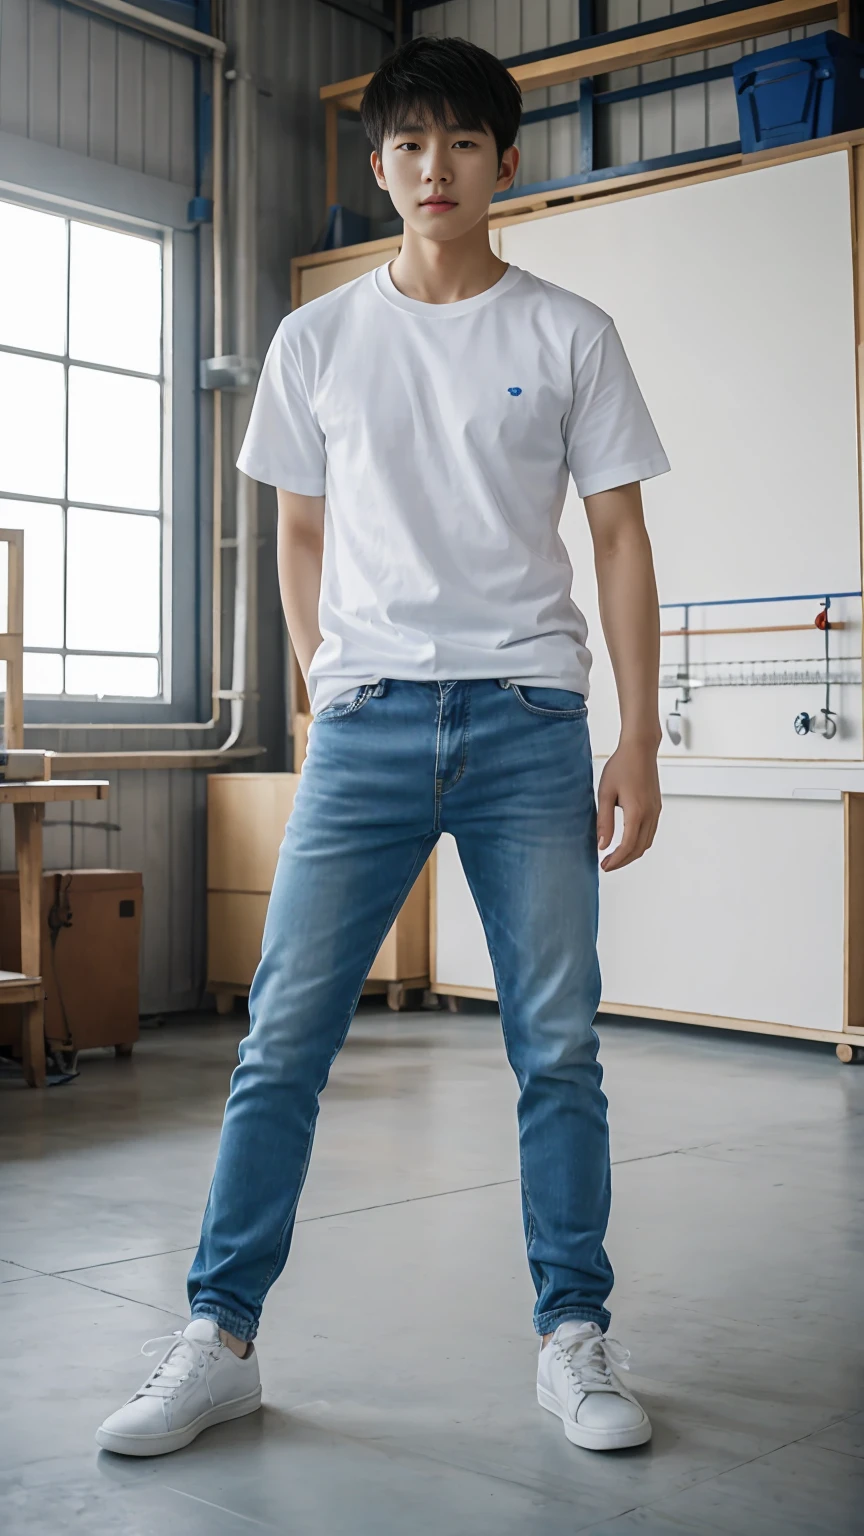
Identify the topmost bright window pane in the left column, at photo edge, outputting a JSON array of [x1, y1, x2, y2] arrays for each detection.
[[0, 203, 66, 356]]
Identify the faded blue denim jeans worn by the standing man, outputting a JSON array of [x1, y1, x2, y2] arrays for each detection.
[[189, 679, 612, 1339]]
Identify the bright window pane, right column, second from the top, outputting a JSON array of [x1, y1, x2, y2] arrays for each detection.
[[67, 369, 161, 511]]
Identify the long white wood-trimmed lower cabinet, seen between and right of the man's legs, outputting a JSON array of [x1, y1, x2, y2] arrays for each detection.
[[432, 770, 864, 1044]]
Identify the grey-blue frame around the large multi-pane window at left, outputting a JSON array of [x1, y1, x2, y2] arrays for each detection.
[[0, 176, 204, 730]]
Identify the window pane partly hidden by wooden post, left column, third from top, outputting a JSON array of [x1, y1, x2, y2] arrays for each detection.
[[0, 498, 63, 648]]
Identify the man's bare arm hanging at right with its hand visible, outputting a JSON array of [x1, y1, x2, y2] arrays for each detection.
[[584, 481, 661, 871]]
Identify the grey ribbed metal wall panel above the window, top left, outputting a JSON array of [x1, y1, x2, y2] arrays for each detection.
[[0, 0, 194, 186]]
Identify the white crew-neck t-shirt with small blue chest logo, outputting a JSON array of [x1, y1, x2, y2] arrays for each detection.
[[237, 266, 669, 713]]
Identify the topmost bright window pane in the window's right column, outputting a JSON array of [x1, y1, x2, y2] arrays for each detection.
[[69, 223, 161, 373]]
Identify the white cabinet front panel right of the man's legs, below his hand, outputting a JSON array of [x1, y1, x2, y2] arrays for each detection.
[[598, 796, 844, 1029]]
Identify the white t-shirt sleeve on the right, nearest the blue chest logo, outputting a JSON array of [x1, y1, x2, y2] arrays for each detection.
[[564, 321, 670, 498]]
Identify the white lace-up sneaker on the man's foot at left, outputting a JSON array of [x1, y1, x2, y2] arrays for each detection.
[[95, 1318, 261, 1456]]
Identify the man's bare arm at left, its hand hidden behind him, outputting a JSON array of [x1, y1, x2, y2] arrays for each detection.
[[277, 490, 324, 682]]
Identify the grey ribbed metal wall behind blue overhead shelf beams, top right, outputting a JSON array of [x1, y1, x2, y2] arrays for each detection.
[[414, 0, 833, 186]]
